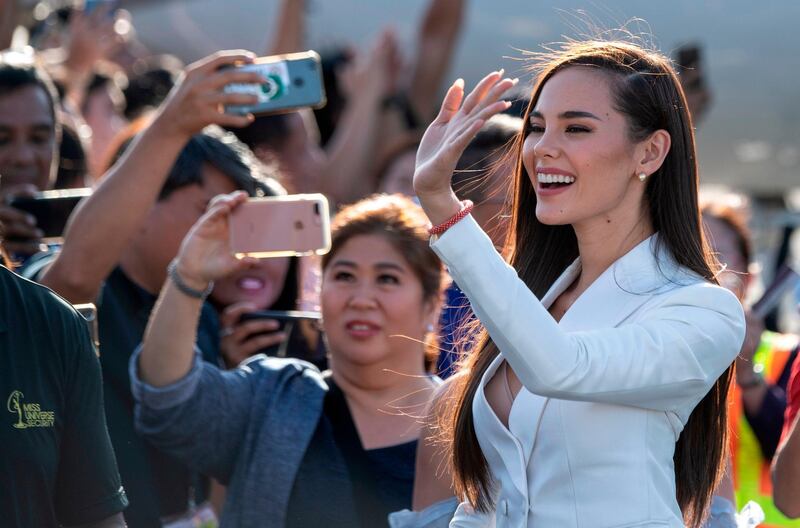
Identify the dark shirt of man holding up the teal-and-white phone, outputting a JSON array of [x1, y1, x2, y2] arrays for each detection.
[[97, 268, 219, 528]]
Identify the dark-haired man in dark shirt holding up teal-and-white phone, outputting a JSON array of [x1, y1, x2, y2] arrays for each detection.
[[40, 52, 263, 528]]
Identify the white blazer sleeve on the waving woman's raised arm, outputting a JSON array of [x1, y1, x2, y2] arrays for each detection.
[[432, 217, 744, 411]]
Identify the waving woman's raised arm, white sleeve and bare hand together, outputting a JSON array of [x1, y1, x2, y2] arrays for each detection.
[[414, 72, 744, 410]]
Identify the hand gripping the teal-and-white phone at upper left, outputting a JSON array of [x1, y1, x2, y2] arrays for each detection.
[[153, 51, 264, 138]]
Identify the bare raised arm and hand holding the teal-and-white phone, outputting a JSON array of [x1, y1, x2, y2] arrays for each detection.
[[40, 52, 261, 303]]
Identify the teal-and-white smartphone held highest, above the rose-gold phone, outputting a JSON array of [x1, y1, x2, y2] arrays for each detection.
[[224, 51, 326, 115]]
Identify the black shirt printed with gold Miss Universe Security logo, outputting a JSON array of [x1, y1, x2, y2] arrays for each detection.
[[0, 266, 127, 528]]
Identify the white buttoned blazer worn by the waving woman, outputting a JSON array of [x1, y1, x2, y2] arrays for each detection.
[[432, 217, 745, 528]]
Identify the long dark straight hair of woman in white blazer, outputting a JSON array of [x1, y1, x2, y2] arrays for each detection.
[[441, 41, 732, 527]]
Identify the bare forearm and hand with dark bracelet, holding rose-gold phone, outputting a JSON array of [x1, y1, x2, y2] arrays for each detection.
[[139, 192, 253, 387]]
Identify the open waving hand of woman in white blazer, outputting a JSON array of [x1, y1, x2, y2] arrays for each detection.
[[414, 70, 517, 224]]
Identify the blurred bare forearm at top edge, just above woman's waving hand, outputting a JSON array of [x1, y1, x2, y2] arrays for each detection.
[[407, 0, 466, 120]]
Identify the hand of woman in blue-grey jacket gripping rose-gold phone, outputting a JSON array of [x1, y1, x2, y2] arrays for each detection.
[[178, 191, 257, 290]]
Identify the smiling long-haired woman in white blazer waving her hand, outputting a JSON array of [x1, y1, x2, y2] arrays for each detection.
[[414, 41, 744, 528]]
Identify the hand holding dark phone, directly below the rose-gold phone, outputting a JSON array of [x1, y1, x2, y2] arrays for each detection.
[[220, 302, 286, 368]]
